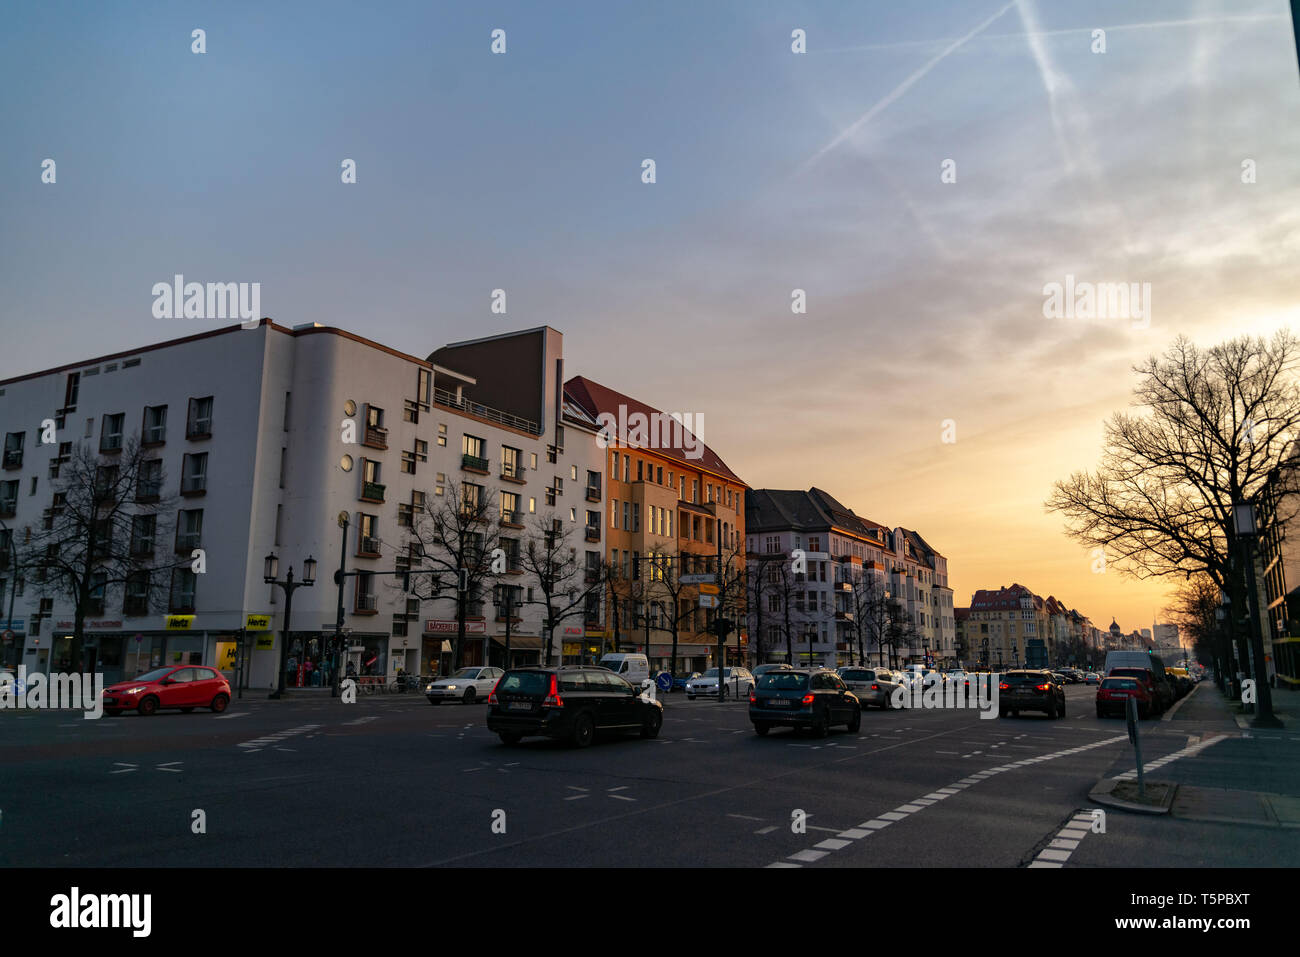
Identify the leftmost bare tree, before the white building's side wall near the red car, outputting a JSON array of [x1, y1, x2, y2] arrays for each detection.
[[20, 436, 178, 671]]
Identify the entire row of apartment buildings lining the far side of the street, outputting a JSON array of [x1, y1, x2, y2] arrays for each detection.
[[0, 320, 1159, 688]]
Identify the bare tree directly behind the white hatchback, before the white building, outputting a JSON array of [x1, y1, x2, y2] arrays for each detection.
[[406, 481, 506, 670]]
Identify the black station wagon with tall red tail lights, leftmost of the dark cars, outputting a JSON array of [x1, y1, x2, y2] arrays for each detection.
[[488, 668, 663, 748]]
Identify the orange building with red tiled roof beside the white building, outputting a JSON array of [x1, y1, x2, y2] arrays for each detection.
[[564, 376, 749, 674]]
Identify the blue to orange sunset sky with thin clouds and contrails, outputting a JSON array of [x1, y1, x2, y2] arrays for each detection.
[[0, 0, 1300, 629]]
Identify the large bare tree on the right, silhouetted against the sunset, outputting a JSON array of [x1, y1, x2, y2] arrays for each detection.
[[1047, 332, 1300, 691]]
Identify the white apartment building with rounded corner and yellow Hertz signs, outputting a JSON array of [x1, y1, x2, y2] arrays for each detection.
[[0, 319, 605, 688]]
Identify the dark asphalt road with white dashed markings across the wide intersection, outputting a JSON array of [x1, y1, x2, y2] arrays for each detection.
[[0, 685, 1300, 867]]
